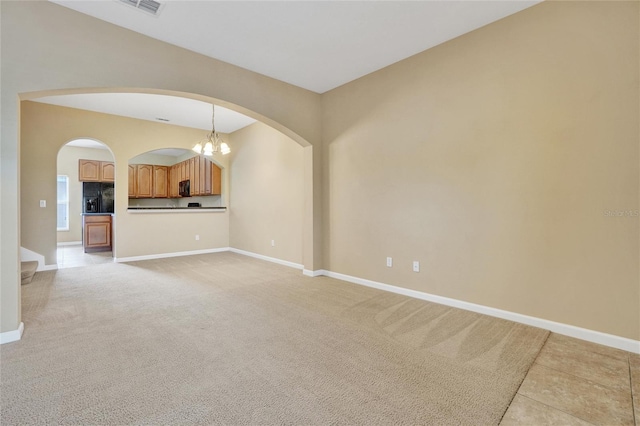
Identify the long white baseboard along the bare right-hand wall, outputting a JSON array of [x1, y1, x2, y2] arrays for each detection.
[[318, 270, 640, 354]]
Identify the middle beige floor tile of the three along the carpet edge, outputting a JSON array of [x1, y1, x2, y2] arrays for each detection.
[[518, 363, 634, 425]]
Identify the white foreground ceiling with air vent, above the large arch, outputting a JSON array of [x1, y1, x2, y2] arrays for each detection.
[[50, 0, 540, 93]]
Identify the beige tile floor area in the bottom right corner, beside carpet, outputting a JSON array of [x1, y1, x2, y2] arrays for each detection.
[[500, 333, 640, 426]]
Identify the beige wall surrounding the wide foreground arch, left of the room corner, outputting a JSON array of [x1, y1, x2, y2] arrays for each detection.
[[0, 1, 321, 332]]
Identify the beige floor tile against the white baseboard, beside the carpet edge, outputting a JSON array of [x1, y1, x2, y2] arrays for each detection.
[[536, 339, 631, 392]]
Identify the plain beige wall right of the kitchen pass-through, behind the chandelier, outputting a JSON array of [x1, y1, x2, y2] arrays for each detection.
[[229, 122, 304, 264]]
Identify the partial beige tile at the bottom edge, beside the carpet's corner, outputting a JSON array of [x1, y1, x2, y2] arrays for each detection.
[[500, 395, 591, 426]]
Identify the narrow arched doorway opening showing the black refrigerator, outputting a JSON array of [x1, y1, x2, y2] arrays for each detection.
[[56, 138, 116, 269]]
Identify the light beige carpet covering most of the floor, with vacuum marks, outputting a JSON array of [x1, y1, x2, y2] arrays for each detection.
[[0, 253, 548, 425]]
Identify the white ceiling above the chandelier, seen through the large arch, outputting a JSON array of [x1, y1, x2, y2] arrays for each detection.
[[34, 93, 256, 133]]
